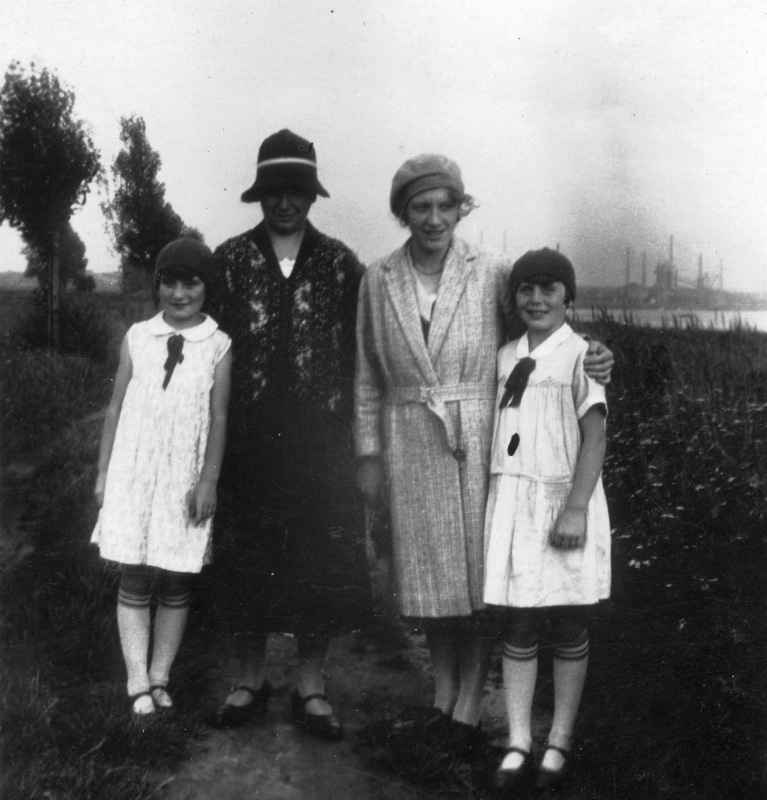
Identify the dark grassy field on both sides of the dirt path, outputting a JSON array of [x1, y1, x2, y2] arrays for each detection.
[[0, 302, 767, 800]]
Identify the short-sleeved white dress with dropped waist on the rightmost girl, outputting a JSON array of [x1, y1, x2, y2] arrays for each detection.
[[484, 325, 610, 608]]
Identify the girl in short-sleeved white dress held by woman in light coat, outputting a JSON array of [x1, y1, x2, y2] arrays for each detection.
[[484, 248, 610, 791]]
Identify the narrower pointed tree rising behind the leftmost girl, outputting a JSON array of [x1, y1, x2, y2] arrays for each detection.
[[101, 116, 195, 285]]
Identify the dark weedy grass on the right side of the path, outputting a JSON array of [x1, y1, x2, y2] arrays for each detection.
[[356, 315, 767, 800]]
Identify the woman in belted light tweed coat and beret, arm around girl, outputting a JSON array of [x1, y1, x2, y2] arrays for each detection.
[[355, 155, 613, 745]]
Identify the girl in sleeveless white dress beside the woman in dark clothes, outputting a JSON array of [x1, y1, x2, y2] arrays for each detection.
[[92, 238, 231, 717]]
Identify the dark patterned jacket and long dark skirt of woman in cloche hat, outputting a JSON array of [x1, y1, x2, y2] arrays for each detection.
[[212, 223, 371, 636]]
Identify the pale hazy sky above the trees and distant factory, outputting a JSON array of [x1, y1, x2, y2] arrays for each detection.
[[0, 0, 767, 292]]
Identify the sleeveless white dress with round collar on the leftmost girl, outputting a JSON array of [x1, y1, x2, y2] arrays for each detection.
[[91, 313, 231, 572]]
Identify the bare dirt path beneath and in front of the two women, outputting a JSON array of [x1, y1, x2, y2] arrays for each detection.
[[166, 635, 500, 800]]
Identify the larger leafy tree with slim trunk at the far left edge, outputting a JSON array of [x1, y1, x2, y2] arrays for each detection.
[[0, 61, 101, 346]]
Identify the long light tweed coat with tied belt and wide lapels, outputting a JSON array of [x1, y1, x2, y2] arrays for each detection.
[[355, 238, 510, 618]]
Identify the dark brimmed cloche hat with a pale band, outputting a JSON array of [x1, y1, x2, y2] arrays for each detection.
[[240, 128, 330, 203]]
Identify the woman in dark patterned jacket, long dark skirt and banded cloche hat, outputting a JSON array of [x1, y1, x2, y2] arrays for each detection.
[[211, 130, 370, 739]]
